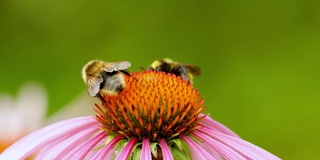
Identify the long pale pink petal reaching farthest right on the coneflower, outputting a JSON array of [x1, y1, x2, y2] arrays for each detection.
[[197, 127, 280, 160]]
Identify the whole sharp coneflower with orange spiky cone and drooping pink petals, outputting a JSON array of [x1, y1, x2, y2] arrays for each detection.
[[1, 71, 279, 160]]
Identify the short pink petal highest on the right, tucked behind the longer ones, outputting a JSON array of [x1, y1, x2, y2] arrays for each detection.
[[199, 114, 240, 137]]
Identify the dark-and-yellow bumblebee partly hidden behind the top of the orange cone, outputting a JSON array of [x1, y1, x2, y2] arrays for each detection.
[[149, 58, 201, 83]]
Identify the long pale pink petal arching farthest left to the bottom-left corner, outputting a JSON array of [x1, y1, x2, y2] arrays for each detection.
[[1, 116, 100, 159]]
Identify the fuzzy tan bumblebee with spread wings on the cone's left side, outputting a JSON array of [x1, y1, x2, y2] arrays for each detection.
[[82, 60, 131, 99]]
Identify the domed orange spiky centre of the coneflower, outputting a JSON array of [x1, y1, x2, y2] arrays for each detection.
[[94, 70, 205, 141]]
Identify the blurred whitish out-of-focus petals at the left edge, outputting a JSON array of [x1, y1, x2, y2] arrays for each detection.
[[0, 83, 47, 144]]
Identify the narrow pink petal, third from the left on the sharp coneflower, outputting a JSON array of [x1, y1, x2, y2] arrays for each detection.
[[64, 131, 107, 159]]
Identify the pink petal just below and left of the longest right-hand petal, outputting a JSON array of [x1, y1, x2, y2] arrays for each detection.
[[191, 131, 246, 160]]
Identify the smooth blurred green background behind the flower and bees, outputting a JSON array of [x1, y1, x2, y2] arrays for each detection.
[[0, 0, 320, 159]]
